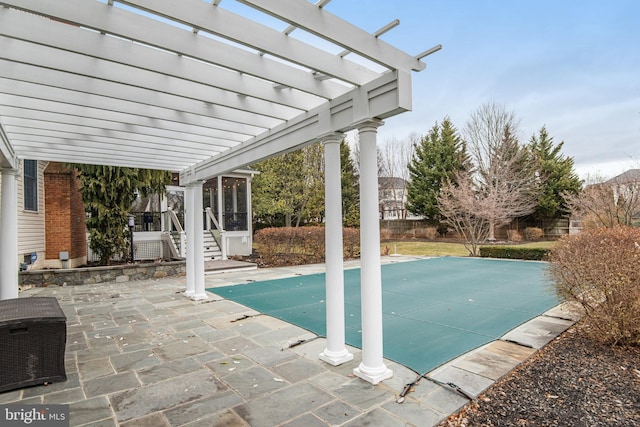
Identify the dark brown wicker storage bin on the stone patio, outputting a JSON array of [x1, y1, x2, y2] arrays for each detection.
[[0, 297, 67, 392]]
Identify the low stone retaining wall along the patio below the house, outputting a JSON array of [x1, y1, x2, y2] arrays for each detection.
[[18, 261, 186, 289]]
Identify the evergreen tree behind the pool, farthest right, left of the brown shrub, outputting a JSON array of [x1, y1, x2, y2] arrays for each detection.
[[530, 126, 582, 226]]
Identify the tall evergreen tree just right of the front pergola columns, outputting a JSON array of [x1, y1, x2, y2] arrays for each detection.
[[407, 117, 470, 231]]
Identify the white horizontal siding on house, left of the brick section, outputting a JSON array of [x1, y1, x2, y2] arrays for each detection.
[[17, 161, 48, 269]]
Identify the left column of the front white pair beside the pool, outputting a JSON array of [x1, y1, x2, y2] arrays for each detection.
[[320, 134, 353, 366]]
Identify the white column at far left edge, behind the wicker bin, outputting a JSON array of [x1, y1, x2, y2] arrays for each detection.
[[0, 169, 18, 300]]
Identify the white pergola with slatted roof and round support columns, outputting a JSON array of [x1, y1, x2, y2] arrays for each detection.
[[0, 0, 439, 384]]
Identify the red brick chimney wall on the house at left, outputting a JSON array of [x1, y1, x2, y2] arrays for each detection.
[[44, 163, 87, 264]]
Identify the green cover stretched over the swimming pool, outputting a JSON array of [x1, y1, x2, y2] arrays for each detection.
[[207, 257, 559, 373]]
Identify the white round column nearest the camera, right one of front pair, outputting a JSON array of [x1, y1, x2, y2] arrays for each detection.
[[353, 120, 393, 384]]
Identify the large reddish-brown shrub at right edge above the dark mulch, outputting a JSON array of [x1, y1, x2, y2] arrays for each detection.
[[549, 226, 640, 345]]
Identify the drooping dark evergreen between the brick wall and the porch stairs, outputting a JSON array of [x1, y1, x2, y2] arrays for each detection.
[[73, 165, 171, 265]]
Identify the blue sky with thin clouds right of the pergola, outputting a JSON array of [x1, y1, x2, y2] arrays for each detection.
[[316, 0, 640, 178]]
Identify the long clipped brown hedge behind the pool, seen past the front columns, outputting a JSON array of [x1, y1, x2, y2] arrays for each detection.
[[254, 226, 360, 265]]
